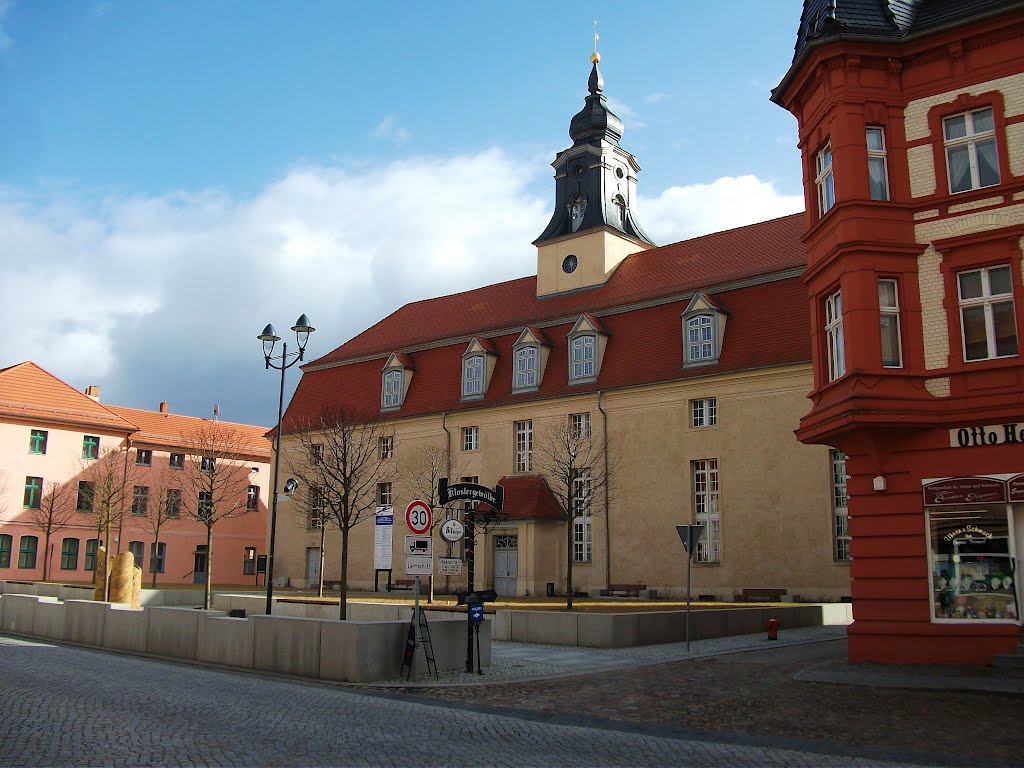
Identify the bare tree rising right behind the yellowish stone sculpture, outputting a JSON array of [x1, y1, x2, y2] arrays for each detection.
[[76, 447, 138, 600]]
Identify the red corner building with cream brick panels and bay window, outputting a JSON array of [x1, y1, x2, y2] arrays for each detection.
[[772, 0, 1024, 664]]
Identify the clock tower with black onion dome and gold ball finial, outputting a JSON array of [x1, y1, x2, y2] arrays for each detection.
[[534, 51, 653, 296]]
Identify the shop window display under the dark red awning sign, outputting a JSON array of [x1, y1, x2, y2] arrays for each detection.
[[928, 509, 1020, 621]]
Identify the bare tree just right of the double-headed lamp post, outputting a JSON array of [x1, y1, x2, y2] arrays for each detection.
[[288, 407, 394, 620]]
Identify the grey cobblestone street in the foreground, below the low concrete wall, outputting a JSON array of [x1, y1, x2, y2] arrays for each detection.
[[0, 637, 978, 768]]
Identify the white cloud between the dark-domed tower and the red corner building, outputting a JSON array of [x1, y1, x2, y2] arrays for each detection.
[[637, 176, 804, 245]]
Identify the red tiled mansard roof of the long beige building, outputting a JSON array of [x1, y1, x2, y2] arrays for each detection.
[[284, 215, 811, 432]]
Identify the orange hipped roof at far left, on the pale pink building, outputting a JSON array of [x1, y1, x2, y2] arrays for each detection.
[[0, 360, 136, 434]]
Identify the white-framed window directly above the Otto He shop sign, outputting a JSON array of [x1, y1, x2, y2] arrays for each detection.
[[956, 265, 1017, 361]]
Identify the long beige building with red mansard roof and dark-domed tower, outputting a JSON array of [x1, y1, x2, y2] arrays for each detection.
[[275, 59, 849, 600]]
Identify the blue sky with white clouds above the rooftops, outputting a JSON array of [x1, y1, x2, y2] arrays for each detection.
[[0, 0, 803, 426]]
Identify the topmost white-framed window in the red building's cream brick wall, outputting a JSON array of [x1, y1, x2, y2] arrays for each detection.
[[942, 106, 999, 194]]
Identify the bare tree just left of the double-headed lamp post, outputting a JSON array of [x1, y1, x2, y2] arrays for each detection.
[[181, 421, 252, 609]]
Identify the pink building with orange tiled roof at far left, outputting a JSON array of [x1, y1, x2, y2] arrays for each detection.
[[0, 361, 270, 586]]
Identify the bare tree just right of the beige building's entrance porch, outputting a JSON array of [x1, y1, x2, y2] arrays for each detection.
[[535, 414, 617, 610]]
